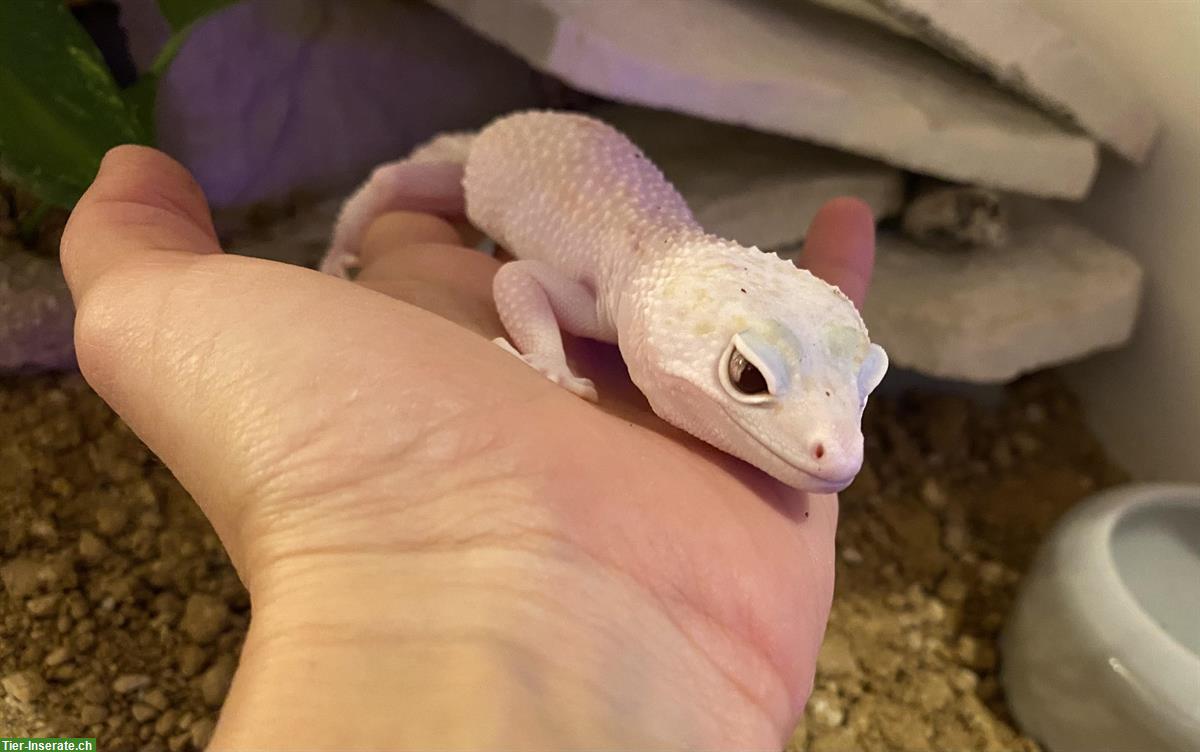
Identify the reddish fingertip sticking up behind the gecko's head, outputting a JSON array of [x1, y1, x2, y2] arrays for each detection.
[[800, 197, 875, 308]]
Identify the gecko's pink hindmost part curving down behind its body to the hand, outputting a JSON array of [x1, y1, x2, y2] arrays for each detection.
[[319, 133, 475, 278]]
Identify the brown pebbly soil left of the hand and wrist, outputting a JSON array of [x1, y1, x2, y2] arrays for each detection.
[[0, 375, 250, 752]]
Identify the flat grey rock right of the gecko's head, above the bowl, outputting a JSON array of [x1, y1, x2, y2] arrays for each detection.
[[863, 201, 1142, 383]]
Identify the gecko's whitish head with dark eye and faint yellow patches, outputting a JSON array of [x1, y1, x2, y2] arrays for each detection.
[[626, 254, 888, 493]]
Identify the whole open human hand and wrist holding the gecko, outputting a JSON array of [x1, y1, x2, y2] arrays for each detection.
[[62, 148, 874, 748]]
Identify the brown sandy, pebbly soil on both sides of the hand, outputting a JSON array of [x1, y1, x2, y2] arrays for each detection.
[[0, 375, 1123, 752]]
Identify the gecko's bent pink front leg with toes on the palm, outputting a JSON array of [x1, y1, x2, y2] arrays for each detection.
[[492, 259, 617, 402]]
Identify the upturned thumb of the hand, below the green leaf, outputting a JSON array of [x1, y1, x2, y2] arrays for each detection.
[[61, 146, 221, 299]]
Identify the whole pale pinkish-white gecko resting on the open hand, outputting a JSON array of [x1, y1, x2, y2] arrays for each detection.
[[322, 112, 888, 493]]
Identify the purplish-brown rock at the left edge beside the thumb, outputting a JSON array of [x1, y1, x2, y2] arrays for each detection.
[[0, 237, 76, 371]]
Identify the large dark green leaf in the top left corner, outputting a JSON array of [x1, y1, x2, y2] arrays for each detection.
[[0, 0, 150, 206]]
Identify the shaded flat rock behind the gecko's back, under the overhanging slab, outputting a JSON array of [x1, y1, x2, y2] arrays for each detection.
[[593, 106, 904, 248]]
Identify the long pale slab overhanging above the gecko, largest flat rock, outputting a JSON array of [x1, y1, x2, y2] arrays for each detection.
[[433, 0, 1097, 199]]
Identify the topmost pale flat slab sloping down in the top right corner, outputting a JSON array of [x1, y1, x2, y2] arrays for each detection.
[[815, 0, 1159, 163]]
